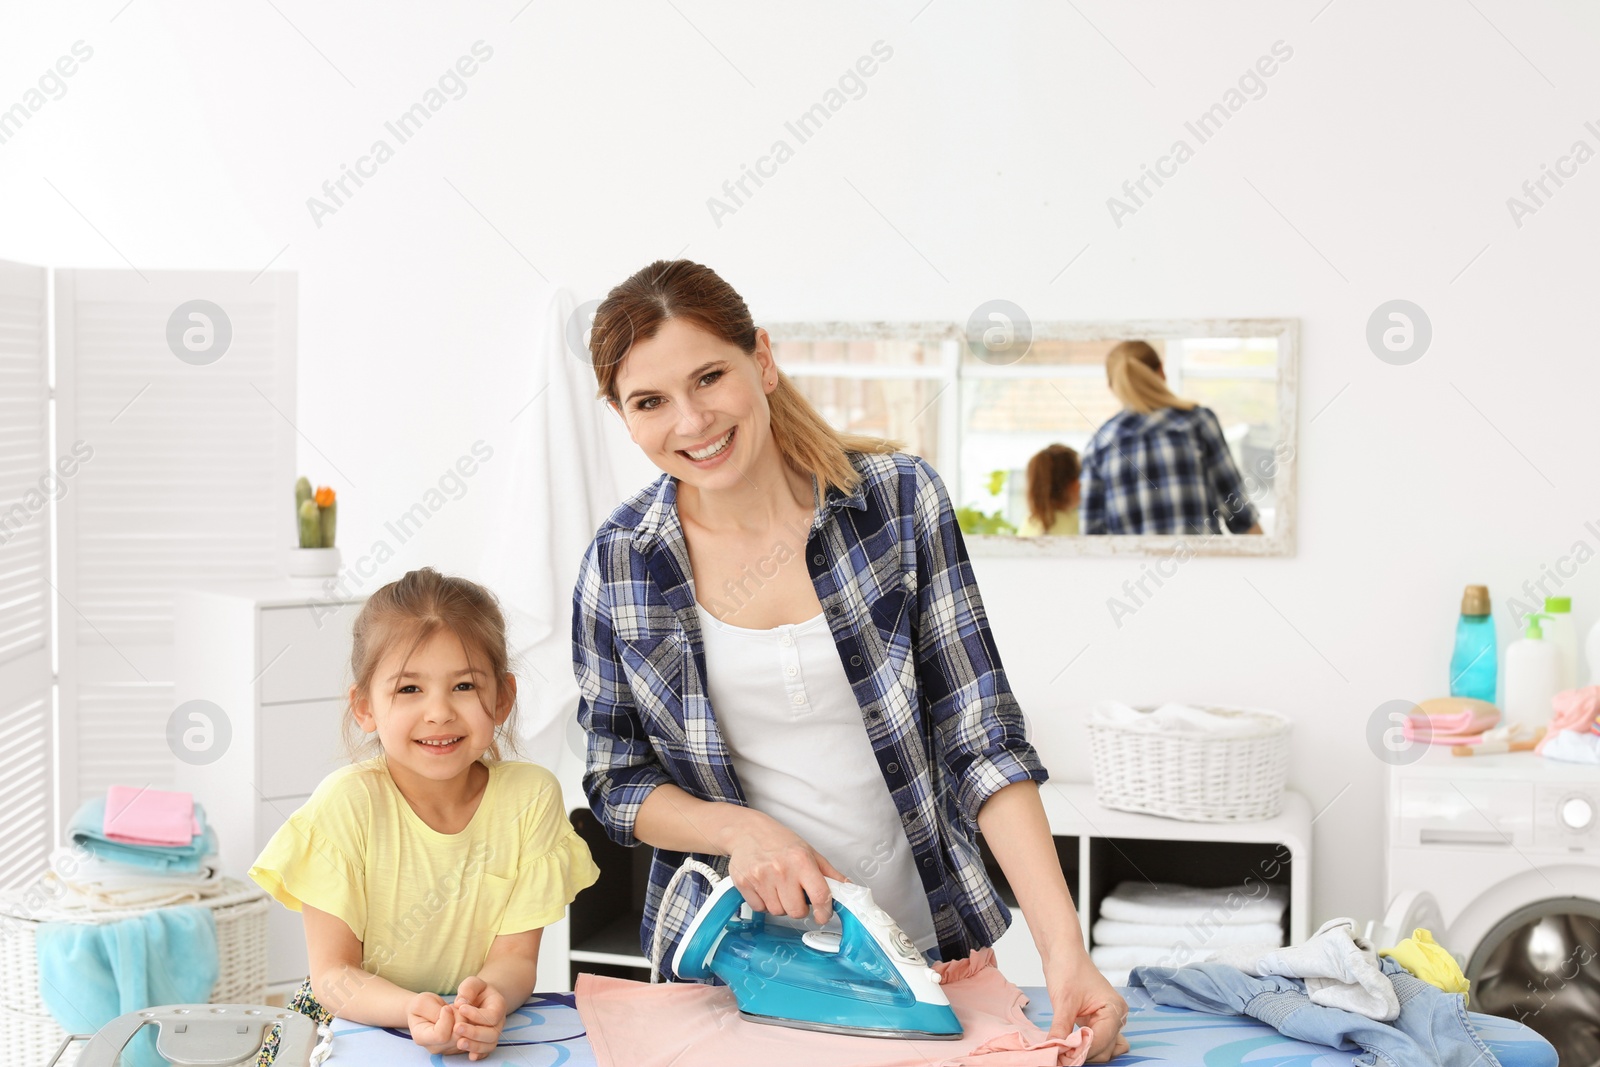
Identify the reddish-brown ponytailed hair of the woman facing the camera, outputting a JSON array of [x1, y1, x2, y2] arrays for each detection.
[[589, 259, 901, 494]]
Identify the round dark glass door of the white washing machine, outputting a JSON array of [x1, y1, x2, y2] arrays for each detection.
[[1467, 896, 1600, 1067]]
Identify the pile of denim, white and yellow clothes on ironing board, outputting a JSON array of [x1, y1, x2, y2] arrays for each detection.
[[1128, 918, 1478, 1067]]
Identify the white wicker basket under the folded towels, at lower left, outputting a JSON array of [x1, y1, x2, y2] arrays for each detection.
[[0, 878, 272, 1067]]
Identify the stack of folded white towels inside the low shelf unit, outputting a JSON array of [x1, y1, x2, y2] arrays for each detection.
[[1090, 881, 1288, 985]]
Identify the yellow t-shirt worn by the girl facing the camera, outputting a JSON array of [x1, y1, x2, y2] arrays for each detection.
[[250, 757, 600, 995]]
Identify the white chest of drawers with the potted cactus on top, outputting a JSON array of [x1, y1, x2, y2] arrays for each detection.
[[170, 581, 362, 985]]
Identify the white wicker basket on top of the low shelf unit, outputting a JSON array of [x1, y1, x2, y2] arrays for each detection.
[[1090, 707, 1290, 822]]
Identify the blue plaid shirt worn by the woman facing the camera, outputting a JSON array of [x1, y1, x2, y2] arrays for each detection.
[[573, 453, 1048, 977]]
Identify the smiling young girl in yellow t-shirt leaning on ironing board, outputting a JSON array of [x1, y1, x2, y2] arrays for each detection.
[[250, 568, 600, 1064]]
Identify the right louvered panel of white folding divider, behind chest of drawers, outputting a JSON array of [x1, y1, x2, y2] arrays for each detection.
[[54, 270, 298, 857]]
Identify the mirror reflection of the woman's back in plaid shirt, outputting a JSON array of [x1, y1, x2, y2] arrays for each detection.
[[1083, 341, 1261, 534]]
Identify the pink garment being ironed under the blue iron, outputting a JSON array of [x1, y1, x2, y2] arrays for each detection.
[[576, 949, 1094, 1067]]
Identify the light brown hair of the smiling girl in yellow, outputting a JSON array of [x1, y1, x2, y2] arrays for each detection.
[[342, 566, 517, 761]]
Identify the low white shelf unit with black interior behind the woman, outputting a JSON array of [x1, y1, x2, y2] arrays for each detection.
[[566, 782, 1312, 985]]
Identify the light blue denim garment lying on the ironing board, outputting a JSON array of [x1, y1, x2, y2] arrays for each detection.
[[1128, 963, 1499, 1067]]
